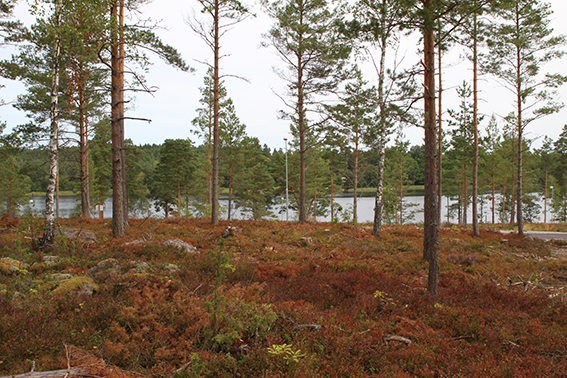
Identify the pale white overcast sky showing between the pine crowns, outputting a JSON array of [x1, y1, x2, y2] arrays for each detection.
[[0, 0, 567, 149]]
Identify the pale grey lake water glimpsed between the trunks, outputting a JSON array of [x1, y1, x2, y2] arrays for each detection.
[[22, 196, 552, 224]]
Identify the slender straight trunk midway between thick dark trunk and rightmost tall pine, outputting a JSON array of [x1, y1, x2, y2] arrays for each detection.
[[472, 6, 480, 236]]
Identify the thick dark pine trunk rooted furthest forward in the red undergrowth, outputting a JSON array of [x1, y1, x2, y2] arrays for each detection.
[[423, 0, 439, 296]]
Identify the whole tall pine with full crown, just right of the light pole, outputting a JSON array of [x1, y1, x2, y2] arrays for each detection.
[[264, 0, 350, 223]]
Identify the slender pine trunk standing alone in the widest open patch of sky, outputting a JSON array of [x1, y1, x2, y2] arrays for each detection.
[[211, 0, 220, 224]]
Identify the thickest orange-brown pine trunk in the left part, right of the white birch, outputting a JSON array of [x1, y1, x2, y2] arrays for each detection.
[[111, 0, 126, 237]]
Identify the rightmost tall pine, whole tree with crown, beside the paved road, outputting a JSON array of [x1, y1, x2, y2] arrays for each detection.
[[484, 0, 567, 234]]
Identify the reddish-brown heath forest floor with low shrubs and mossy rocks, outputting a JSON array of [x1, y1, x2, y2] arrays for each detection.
[[0, 216, 567, 378]]
